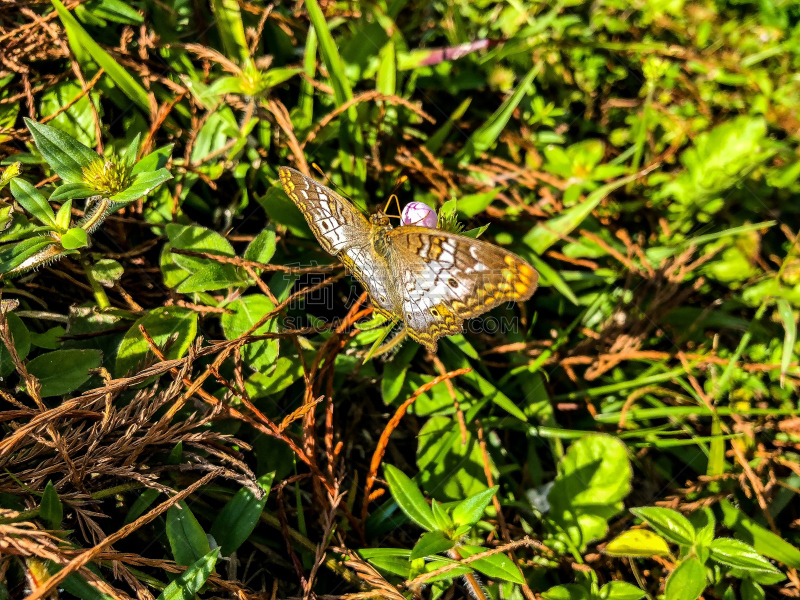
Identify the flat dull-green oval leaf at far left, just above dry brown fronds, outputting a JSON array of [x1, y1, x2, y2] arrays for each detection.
[[27, 350, 103, 398]]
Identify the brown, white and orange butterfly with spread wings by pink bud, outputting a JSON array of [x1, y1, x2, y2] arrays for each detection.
[[279, 167, 539, 352]]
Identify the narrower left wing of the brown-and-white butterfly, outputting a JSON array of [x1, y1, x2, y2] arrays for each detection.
[[279, 167, 396, 317]]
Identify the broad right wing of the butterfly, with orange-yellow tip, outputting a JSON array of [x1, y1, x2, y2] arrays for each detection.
[[387, 226, 539, 351]]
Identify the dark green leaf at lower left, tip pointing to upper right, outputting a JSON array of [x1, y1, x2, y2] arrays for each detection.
[[211, 471, 275, 556]]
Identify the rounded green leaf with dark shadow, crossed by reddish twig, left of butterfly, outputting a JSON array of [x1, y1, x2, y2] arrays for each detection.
[[115, 306, 197, 377]]
